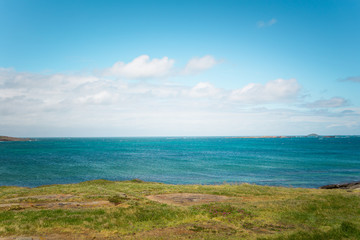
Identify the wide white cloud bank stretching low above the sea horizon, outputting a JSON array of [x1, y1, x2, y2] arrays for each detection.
[[0, 55, 360, 136]]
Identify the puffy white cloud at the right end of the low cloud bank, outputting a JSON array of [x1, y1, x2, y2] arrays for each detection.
[[230, 79, 301, 103]]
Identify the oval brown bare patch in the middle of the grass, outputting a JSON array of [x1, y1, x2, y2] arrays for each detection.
[[147, 193, 229, 206]]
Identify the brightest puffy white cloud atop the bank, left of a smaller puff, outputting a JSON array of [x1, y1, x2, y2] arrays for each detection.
[[105, 55, 175, 79]]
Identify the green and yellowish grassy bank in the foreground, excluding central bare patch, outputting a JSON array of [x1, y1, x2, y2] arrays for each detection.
[[0, 180, 360, 239]]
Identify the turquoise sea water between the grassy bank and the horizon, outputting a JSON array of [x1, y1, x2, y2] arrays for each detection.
[[0, 137, 360, 187]]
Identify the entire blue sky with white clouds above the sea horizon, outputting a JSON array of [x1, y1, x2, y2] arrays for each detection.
[[0, 0, 360, 137]]
